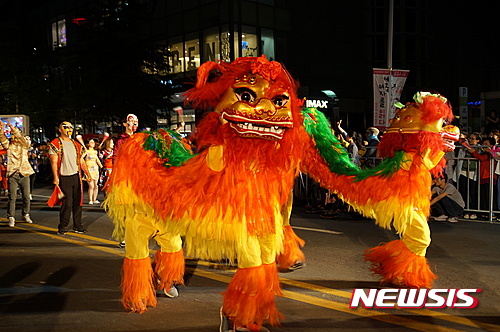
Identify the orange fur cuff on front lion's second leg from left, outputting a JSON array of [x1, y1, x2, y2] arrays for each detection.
[[154, 249, 185, 289]]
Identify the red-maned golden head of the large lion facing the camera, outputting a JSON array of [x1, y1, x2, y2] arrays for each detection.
[[186, 56, 299, 141]]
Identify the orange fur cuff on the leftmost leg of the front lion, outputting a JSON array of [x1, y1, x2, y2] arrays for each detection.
[[121, 257, 156, 314]]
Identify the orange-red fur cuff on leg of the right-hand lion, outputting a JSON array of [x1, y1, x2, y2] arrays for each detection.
[[365, 240, 437, 288]]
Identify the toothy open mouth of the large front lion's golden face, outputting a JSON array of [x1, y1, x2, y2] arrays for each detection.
[[221, 112, 293, 140]]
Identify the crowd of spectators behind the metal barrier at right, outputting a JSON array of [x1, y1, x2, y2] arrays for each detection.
[[305, 115, 500, 222]]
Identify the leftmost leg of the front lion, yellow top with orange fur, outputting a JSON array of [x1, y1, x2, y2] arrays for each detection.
[[122, 213, 156, 313]]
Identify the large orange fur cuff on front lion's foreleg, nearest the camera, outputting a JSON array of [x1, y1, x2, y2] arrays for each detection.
[[222, 263, 283, 331]]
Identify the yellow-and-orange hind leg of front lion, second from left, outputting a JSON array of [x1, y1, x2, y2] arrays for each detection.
[[154, 233, 185, 291]]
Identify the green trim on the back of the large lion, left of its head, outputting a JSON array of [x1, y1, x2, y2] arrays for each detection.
[[143, 129, 195, 168]]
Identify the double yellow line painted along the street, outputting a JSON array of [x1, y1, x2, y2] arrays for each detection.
[[8, 218, 500, 331]]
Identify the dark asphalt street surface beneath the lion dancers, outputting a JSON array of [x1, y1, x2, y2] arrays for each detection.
[[0, 180, 500, 332]]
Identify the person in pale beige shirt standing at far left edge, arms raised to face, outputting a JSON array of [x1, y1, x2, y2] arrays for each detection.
[[0, 124, 35, 227]]
